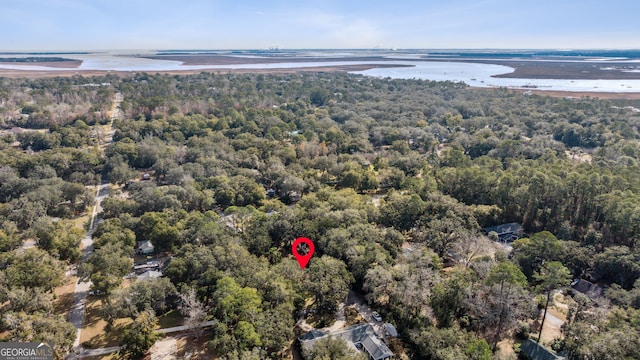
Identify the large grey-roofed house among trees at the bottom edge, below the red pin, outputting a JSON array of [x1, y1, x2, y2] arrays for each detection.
[[298, 324, 393, 360]]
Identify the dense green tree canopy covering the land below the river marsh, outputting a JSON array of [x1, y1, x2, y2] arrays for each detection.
[[0, 73, 640, 359]]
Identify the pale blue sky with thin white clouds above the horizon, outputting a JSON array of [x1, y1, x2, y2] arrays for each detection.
[[0, 0, 640, 51]]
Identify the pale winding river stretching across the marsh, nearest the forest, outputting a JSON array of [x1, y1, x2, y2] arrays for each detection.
[[0, 54, 640, 92]]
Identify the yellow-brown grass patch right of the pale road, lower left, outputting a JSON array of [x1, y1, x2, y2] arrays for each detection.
[[80, 299, 131, 349]]
